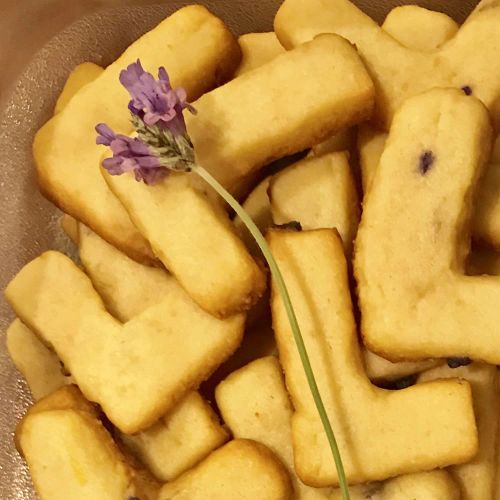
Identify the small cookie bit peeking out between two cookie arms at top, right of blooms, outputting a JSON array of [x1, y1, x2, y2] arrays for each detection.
[[235, 31, 285, 76]]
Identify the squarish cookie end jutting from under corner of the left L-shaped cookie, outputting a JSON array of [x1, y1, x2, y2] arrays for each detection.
[[120, 391, 229, 481]]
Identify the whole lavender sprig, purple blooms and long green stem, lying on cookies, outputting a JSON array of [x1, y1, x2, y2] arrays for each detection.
[[96, 60, 350, 500]]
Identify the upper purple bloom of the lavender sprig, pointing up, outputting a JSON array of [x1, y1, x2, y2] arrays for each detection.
[[120, 59, 195, 135]]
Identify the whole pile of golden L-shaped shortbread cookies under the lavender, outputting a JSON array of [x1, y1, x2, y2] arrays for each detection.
[[5, 0, 500, 500]]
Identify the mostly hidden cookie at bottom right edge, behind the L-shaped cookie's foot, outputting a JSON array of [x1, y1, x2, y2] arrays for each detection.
[[418, 363, 500, 500]]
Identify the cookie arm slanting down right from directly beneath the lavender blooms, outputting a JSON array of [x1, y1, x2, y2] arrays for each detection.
[[103, 171, 266, 317]]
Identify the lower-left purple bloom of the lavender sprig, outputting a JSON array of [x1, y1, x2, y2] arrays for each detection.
[[95, 123, 168, 185]]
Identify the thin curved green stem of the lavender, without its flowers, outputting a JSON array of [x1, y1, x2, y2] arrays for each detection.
[[193, 165, 350, 500]]
